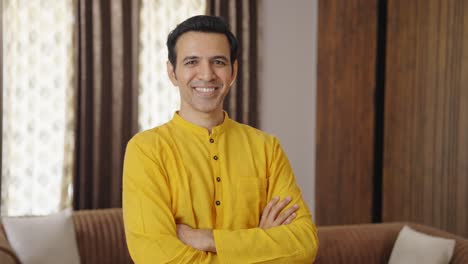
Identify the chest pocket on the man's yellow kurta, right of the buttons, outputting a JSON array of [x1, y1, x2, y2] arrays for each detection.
[[235, 177, 267, 228]]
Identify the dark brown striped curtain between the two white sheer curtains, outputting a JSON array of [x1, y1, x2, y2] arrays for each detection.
[[73, 0, 139, 209]]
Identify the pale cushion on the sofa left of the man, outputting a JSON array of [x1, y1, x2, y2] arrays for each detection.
[[3, 210, 80, 264]]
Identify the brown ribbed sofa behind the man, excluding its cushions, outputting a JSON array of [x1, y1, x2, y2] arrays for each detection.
[[0, 209, 468, 264]]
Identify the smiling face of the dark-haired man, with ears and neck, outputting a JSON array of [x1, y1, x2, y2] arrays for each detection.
[[167, 32, 237, 114]]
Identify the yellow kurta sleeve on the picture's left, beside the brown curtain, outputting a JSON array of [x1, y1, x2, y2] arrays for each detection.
[[123, 137, 218, 264]]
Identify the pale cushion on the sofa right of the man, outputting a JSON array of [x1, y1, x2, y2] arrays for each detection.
[[388, 226, 455, 264]]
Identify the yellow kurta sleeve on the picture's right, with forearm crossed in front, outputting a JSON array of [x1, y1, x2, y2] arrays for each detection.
[[213, 138, 318, 264]]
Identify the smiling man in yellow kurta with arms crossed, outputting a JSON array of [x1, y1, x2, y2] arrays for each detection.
[[123, 16, 318, 264]]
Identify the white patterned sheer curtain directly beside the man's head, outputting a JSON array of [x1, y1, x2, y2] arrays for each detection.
[[138, 0, 206, 130]]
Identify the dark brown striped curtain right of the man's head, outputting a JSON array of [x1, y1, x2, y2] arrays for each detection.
[[206, 0, 259, 127]]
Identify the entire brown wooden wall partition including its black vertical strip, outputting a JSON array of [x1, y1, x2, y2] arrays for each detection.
[[316, 0, 468, 237]]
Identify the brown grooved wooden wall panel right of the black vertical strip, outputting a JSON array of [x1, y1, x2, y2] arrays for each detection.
[[382, 0, 468, 237]]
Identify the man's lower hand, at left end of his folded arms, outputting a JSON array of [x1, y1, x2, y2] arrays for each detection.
[[176, 224, 216, 253]]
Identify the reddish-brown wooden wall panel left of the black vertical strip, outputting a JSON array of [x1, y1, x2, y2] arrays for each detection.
[[316, 0, 377, 225]]
